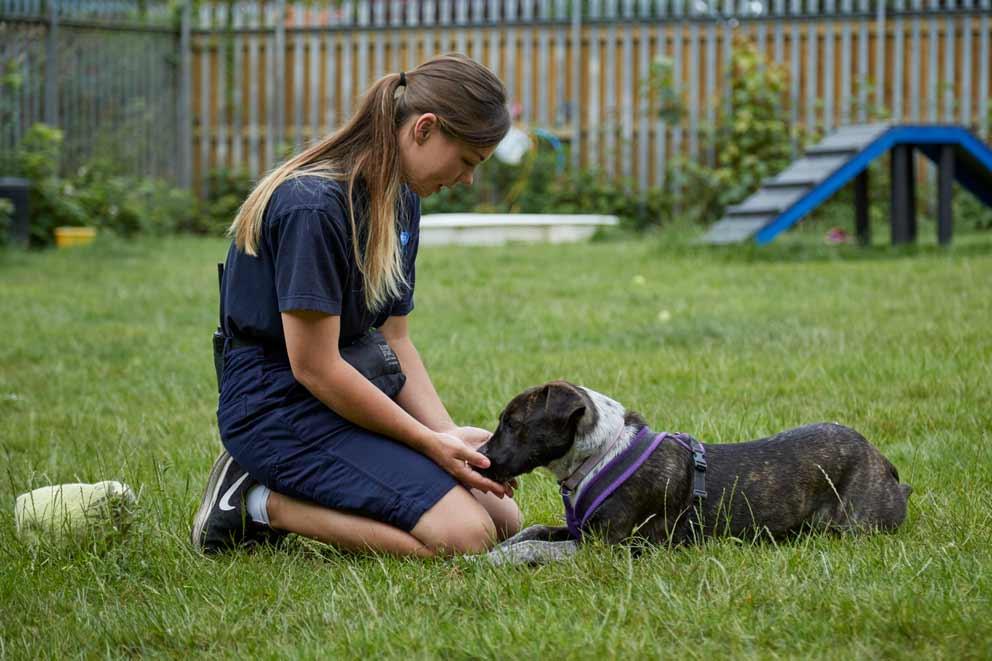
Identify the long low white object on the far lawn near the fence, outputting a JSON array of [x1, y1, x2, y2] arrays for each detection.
[[420, 213, 620, 246]]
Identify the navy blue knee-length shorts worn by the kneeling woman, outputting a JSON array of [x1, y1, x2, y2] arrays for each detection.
[[217, 347, 458, 532]]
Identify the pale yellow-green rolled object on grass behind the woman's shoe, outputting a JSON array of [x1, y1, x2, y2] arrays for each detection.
[[14, 480, 137, 543]]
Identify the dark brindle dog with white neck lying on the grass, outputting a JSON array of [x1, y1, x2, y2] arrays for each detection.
[[480, 381, 912, 563]]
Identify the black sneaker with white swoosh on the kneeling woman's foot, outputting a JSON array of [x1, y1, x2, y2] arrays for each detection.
[[190, 450, 285, 553]]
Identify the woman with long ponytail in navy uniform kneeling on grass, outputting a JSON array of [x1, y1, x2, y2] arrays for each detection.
[[191, 54, 521, 556]]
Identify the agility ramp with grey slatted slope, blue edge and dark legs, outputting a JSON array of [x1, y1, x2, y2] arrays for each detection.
[[702, 124, 992, 245]]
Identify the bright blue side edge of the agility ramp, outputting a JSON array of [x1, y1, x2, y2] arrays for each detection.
[[700, 125, 992, 245]]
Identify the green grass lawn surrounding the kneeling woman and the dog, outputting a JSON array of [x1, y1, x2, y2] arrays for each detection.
[[0, 229, 992, 659]]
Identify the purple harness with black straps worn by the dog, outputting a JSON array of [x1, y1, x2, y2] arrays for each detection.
[[561, 426, 706, 540]]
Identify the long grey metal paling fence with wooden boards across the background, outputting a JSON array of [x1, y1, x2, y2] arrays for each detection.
[[0, 0, 992, 193]]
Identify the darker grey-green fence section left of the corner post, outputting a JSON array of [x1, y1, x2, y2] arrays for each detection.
[[0, 0, 182, 181]]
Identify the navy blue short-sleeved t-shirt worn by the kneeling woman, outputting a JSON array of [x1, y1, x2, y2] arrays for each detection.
[[221, 176, 420, 347]]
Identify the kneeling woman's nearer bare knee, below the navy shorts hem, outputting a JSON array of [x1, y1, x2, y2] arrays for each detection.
[[410, 487, 497, 554]]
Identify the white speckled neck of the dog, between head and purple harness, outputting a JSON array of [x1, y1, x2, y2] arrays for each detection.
[[547, 388, 638, 494]]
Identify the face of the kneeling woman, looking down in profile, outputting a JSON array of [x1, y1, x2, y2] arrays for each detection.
[[399, 113, 496, 198]]
